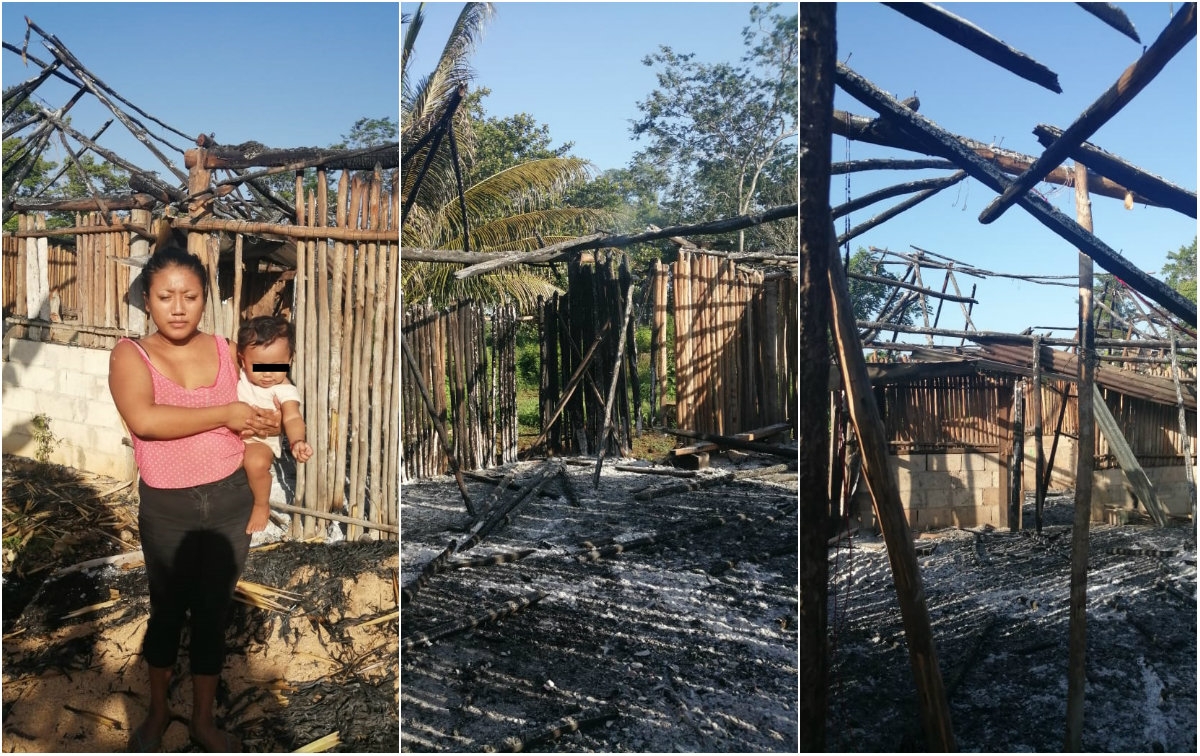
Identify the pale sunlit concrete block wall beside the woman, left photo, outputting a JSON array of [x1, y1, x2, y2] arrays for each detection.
[[2, 338, 137, 480]]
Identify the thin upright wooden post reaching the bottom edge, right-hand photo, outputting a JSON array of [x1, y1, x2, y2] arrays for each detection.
[[1064, 161, 1096, 752]]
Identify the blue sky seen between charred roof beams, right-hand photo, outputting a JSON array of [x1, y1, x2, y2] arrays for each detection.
[[832, 2, 1196, 344]]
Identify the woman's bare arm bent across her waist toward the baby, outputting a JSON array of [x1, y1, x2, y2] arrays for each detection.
[[108, 342, 254, 440]]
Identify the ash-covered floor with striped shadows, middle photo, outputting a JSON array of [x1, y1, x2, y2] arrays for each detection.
[[401, 458, 798, 752]]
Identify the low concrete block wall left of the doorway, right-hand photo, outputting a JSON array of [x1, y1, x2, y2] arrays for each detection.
[[853, 452, 1008, 530]]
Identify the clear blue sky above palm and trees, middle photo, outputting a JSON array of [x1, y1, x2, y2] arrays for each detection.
[[401, 2, 777, 170]]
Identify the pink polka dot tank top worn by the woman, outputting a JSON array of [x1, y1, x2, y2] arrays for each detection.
[[121, 336, 245, 488]]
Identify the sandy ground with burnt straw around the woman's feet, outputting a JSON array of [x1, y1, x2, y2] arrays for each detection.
[[2, 541, 398, 752]]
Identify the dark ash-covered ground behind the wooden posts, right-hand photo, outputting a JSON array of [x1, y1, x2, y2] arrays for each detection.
[[827, 497, 1196, 754]]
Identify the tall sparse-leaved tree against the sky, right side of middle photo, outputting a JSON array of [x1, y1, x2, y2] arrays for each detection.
[[632, 4, 798, 251]]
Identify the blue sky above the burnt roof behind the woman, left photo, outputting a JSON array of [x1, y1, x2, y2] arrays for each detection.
[[0, 2, 400, 182]]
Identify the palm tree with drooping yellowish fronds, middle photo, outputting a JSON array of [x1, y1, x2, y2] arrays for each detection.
[[401, 2, 606, 310]]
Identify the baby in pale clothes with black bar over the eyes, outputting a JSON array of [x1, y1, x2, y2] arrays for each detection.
[[238, 316, 312, 533]]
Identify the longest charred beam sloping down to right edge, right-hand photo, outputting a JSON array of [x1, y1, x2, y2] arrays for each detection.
[[838, 62, 1196, 323]]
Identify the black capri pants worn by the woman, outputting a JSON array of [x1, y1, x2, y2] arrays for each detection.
[[138, 467, 254, 674]]
